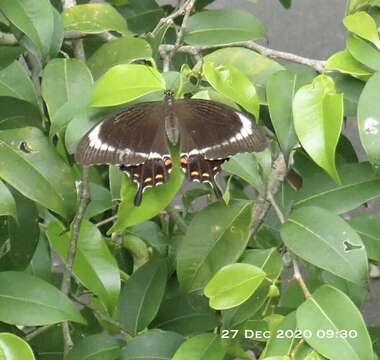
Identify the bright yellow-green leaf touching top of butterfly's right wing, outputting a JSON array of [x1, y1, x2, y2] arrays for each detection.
[[203, 62, 260, 118]]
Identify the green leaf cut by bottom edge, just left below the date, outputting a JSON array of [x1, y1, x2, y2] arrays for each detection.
[[172, 334, 225, 360]]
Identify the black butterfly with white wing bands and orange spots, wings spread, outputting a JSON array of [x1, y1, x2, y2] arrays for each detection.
[[75, 90, 267, 206]]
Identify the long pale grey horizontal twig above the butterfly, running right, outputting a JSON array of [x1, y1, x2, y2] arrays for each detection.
[[160, 41, 326, 72]]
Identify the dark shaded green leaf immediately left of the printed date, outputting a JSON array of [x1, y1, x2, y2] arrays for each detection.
[[151, 289, 219, 336]]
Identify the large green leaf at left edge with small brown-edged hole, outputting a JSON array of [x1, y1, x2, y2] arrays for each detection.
[[0, 128, 76, 216]]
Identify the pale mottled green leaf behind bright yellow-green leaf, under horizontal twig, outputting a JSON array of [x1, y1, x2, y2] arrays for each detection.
[[203, 47, 284, 104]]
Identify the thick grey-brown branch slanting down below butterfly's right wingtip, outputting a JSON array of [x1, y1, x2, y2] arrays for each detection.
[[250, 153, 287, 236]]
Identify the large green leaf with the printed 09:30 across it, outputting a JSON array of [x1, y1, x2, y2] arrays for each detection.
[[297, 285, 374, 360]]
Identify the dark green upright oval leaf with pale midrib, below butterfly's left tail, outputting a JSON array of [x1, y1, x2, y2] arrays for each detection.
[[118, 260, 168, 335]]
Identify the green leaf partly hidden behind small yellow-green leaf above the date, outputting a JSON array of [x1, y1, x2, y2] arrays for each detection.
[[241, 248, 283, 280]]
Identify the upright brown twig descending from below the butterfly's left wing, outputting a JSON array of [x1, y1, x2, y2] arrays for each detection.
[[61, 166, 90, 354]]
